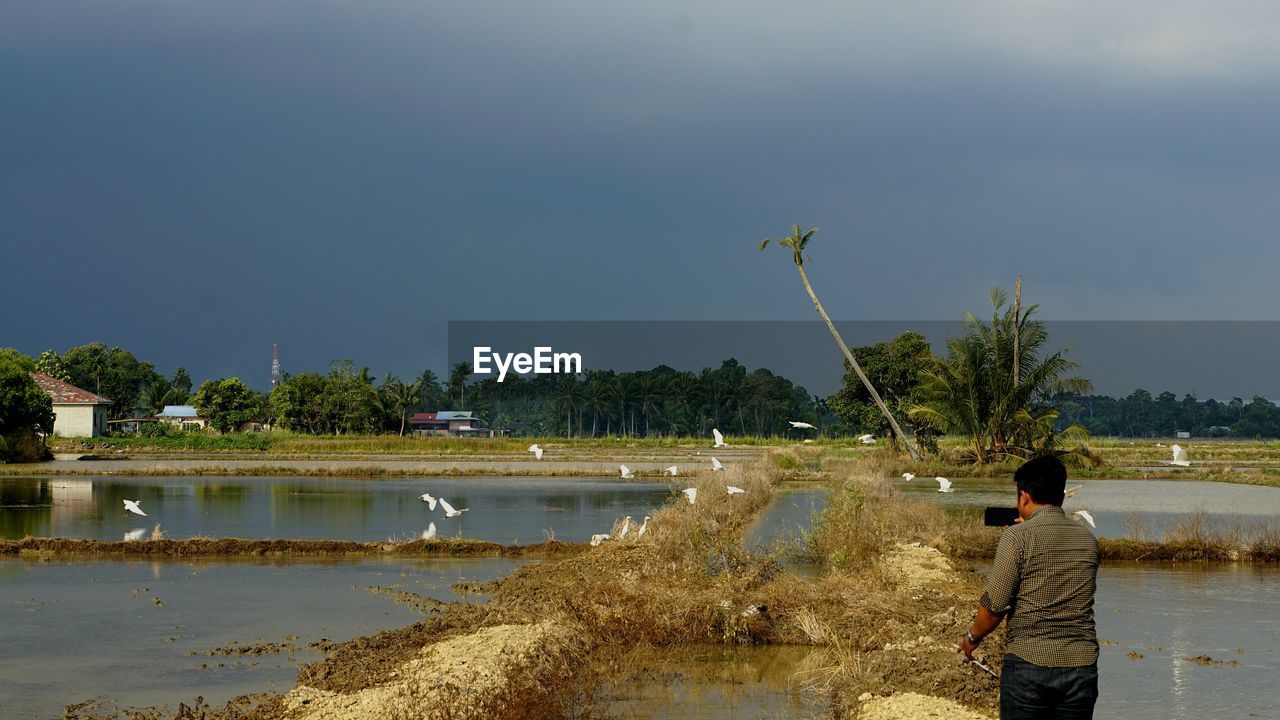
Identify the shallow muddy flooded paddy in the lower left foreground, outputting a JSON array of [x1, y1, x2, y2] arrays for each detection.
[[0, 550, 517, 719]]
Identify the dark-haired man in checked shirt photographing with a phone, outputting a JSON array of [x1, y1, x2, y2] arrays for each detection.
[[960, 456, 1098, 720]]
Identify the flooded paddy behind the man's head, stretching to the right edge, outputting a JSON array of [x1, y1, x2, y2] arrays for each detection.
[[893, 478, 1280, 541]]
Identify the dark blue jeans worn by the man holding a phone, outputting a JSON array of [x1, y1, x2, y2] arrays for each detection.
[[1000, 655, 1098, 720]]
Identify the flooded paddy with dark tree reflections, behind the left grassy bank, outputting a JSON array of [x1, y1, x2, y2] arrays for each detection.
[[0, 477, 675, 544]]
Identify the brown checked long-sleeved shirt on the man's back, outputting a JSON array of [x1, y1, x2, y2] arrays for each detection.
[[980, 507, 1098, 667]]
